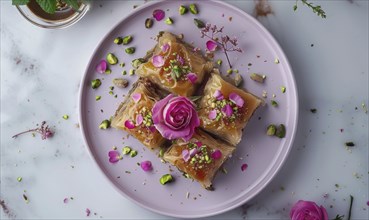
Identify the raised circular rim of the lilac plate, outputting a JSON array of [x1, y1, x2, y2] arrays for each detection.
[[78, 0, 299, 218]]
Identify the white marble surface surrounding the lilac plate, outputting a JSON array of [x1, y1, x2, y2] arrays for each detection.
[[0, 0, 369, 219]]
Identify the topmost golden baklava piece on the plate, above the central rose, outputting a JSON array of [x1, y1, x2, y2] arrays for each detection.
[[136, 32, 212, 97]]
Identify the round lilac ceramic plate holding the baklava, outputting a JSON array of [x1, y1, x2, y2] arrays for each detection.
[[80, 1, 298, 218]]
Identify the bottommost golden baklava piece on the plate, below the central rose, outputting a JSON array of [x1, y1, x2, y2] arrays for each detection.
[[163, 129, 235, 190]]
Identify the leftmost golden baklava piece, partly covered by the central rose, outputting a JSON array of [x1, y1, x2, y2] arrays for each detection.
[[111, 79, 165, 150]]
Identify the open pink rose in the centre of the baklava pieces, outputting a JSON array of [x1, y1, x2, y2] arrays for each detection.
[[152, 94, 200, 141]]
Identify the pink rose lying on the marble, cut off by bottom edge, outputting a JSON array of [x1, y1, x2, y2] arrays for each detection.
[[290, 200, 328, 220]]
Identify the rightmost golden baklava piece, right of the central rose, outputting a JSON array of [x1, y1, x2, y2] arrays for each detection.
[[199, 73, 262, 146]]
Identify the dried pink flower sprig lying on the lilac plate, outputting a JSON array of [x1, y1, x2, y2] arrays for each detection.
[[201, 23, 242, 68]]
